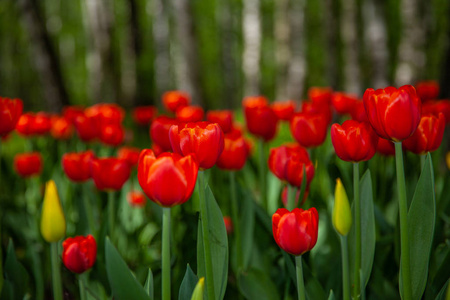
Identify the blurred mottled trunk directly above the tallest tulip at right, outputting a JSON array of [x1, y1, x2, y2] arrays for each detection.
[[395, 0, 426, 86]]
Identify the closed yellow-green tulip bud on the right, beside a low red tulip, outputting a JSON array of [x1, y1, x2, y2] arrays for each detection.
[[333, 178, 352, 235]]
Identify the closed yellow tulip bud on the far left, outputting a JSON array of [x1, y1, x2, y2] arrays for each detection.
[[41, 180, 66, 243]]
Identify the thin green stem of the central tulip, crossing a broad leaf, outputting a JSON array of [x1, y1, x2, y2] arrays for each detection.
[[198, 171, 216, 300]]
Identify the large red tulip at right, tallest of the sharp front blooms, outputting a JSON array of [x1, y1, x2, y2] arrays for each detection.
[[363, 85, 421, 142]]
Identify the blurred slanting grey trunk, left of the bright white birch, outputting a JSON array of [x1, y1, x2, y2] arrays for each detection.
[[172, 0, 203, 105]]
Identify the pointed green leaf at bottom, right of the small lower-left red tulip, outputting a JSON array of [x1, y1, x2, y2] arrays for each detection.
[[105, 238, 150, 300]]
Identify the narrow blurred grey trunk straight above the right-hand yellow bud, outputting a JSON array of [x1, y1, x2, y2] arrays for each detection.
[[341, 0, 361, 95]]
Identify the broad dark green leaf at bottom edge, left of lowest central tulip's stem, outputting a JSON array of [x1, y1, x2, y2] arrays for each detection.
[[238, 269, 280, 300]]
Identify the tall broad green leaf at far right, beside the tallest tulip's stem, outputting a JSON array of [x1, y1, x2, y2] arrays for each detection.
[[400, 153, 436, 299]]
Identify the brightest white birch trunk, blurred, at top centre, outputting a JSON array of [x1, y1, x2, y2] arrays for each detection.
[[242, 0, 261, 96]]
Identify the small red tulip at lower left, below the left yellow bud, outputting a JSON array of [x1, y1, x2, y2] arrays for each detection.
[[62, 234, 97, 274]]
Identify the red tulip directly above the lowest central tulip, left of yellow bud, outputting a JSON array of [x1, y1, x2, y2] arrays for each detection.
[[268, 144, 314, 187]]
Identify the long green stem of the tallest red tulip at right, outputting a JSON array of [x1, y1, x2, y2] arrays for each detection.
[[395, 142, 412, 300]]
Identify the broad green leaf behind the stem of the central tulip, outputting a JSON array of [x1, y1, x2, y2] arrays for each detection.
[[197, 186, 228, 299]]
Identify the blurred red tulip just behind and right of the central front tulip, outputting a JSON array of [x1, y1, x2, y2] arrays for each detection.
[[217, 131, 249, 170]]
